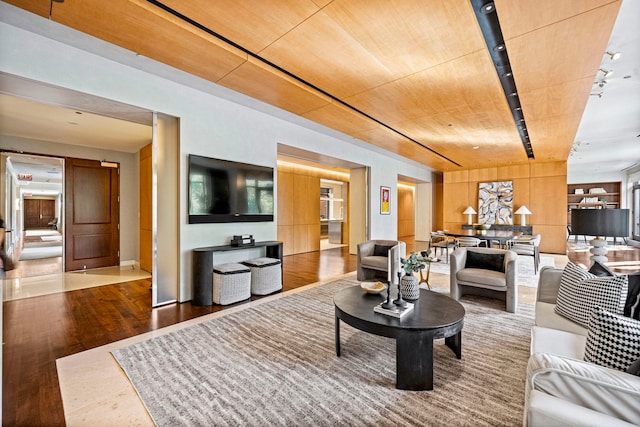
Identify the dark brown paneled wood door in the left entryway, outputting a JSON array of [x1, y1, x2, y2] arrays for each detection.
[[65, 158, 120, 271]]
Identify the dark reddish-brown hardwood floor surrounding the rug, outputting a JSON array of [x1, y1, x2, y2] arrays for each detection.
[[2, 239, 640, 426]]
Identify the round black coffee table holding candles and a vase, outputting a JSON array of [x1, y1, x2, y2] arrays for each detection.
[[333, 286, 465, 390]]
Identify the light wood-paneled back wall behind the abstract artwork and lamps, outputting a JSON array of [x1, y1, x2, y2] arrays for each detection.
[[443, 162, 567, 254]]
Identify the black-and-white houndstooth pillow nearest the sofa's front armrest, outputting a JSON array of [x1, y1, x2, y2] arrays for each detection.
[[584, 307, 640, 371]]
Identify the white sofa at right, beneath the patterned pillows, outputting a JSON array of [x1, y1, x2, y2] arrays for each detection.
[[524, 267, 640, 427]]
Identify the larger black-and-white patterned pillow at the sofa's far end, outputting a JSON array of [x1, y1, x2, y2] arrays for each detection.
[[555, 262, 627, 328]]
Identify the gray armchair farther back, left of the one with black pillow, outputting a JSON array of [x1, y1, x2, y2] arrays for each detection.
[[357, 240, 407, 283]]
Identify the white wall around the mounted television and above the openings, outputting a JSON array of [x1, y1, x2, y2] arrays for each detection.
[[0, 3, 431, 301]]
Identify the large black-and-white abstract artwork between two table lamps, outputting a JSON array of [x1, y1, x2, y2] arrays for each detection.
[[478, 181, 513, 224]]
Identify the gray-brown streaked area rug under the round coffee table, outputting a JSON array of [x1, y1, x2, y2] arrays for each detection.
[[113, 279, 533, 426]]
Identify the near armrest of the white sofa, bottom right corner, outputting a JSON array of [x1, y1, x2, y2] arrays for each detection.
[[525, 353, 640, 424]]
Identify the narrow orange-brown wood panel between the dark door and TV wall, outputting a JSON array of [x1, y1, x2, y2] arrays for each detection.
[[140, 144, 153, 273]]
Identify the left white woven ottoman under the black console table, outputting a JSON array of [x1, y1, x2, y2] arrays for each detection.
[[213, 263, 251, 305]]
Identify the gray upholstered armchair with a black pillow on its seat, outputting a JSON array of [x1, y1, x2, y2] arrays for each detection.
[[449, 248, 518, 313]]
